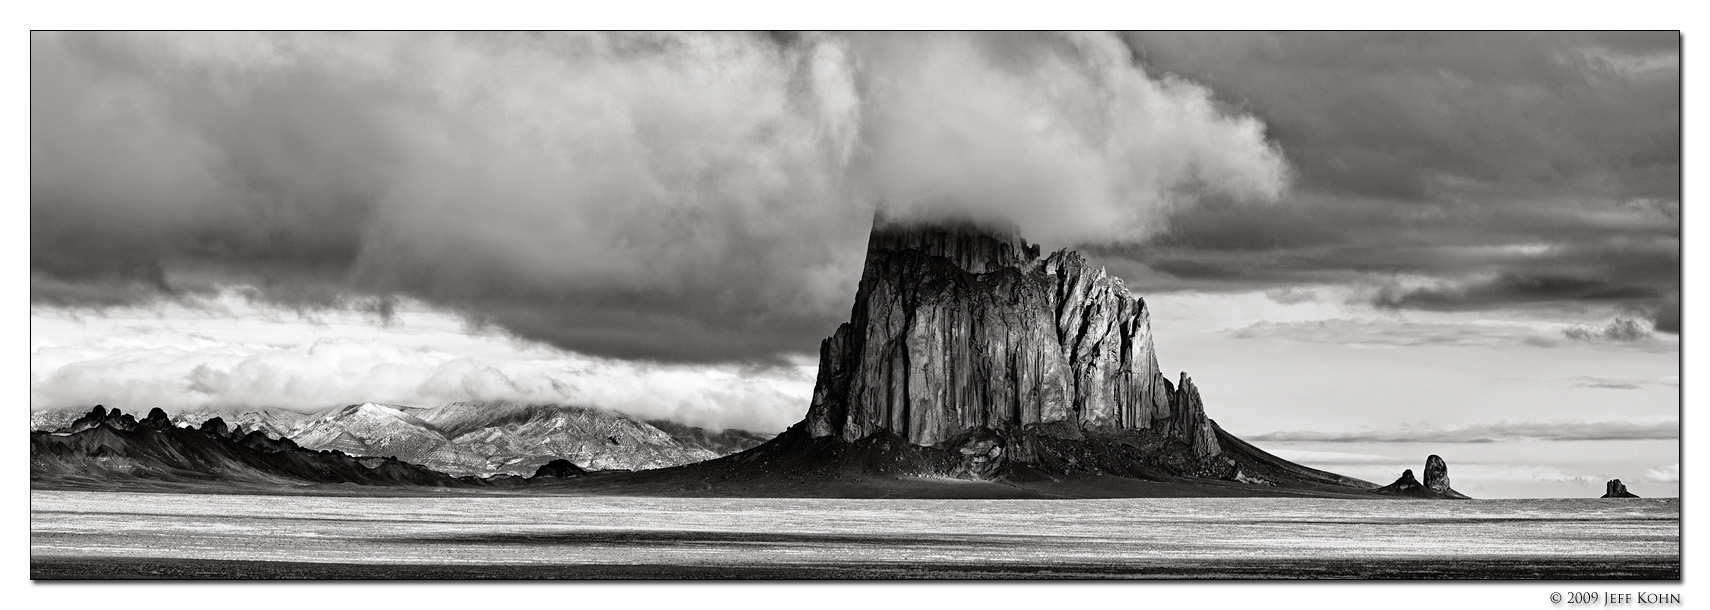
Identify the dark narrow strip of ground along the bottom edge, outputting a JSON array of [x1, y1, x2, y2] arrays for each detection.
[[29, 557, 1681, 581]]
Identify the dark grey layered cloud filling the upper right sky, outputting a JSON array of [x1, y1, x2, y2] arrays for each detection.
[[1100, 32, 1681, 333]]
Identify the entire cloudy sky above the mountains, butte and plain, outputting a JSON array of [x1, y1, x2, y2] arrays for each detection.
[[29, 32, 1681, 497]]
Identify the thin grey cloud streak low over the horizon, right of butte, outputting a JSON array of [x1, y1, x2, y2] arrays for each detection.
[[1250, 422, 1681, 443]]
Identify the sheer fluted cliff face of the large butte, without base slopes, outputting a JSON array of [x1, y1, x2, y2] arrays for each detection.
[[807, 217, 1221, 456]]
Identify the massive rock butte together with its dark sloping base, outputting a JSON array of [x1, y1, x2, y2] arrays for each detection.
[[742, 215, 1375, 489]]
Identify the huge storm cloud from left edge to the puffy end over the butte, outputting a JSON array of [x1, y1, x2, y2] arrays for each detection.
[[31, 32, 1291, 362]]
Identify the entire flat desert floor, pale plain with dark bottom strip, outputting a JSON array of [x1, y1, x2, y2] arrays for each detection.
[[31, 490, 1681, 581]]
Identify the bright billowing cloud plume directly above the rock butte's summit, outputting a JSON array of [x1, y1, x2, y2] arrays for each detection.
[[852, 34, 1288, 241]]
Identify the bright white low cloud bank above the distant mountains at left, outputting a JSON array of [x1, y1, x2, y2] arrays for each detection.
[[31, 294, 812, 432]]
